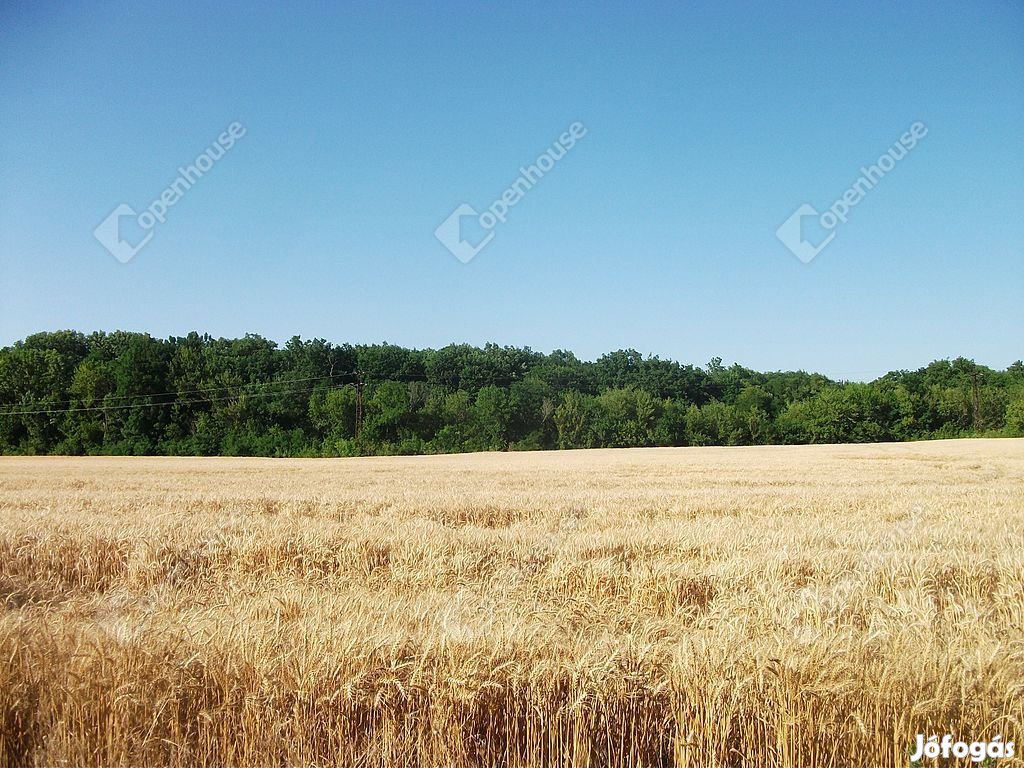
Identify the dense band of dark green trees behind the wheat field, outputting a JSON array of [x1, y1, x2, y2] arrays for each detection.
[[0, 331, 1024, 456]]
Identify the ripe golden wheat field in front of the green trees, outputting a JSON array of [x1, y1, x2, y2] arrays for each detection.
[[0, 439, 1024, 768]]
